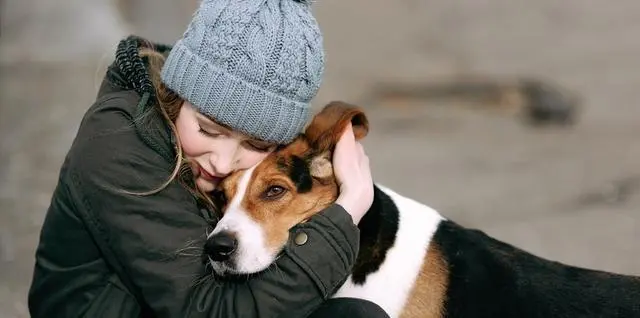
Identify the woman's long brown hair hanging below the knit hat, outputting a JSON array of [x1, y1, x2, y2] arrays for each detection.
[[139, 46, 217, 211]]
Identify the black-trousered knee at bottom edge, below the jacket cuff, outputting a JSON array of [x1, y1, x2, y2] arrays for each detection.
[[309, 298, 390, 318]]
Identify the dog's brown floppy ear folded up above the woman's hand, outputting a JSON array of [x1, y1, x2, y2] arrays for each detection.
[[304, 101, 369, 152]]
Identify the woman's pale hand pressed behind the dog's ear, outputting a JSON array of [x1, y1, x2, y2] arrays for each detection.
[[333, 124, 373, 224]]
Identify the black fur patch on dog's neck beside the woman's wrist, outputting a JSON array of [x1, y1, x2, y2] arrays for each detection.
[[352, 186, 399, 284]]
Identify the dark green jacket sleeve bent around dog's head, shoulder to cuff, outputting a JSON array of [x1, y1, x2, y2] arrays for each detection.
[[67, 98, 359, 318]]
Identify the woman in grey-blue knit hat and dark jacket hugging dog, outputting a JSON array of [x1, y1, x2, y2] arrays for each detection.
[[29, 0, 385, 317]]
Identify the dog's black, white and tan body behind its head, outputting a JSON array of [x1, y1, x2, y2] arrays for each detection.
[[334, 186, 640, 317]]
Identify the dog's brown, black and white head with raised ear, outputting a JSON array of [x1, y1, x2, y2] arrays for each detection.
[[205, 102, 369, 275]]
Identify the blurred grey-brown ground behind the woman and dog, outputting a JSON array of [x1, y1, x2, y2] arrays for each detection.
[[0, 0, 640, 317]]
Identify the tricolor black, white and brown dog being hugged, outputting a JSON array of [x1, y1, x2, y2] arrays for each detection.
[[202, 102, 640, 318]]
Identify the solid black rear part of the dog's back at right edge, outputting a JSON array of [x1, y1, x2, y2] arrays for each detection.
[[432, 221, 640, 318]]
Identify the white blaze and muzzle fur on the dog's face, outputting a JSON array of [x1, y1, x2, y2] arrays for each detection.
[[209, 165, 274, 273]]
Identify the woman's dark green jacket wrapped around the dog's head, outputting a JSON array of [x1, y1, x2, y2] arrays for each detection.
[[29, 38, 359, 318]]
